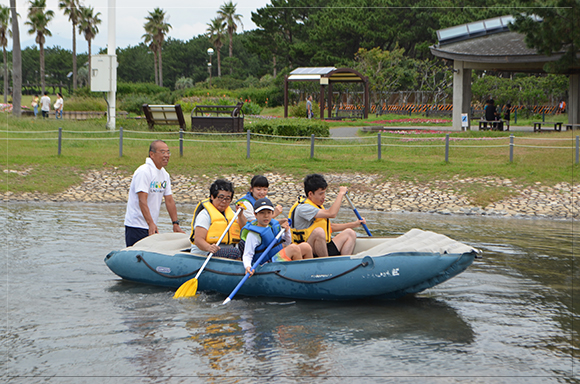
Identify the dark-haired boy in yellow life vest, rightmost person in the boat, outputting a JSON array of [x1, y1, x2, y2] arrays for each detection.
[[288, 174, 366, 257]]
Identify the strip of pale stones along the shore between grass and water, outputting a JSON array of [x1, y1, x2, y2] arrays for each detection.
[[3, 169, 580, 220]]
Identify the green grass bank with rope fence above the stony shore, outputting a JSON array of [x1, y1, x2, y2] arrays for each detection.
[[0, 114, 578, 204]]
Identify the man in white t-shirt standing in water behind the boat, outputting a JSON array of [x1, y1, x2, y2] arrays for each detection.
[[125, 140, 183, 247]]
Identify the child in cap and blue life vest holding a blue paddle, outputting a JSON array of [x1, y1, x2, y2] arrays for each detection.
[[241, 197, 312, 276]]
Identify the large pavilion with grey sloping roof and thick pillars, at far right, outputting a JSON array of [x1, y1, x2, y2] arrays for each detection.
[[431, 16, 580, 131]]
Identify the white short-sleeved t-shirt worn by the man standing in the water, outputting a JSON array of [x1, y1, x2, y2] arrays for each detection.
[[125, 157, 172, 229]]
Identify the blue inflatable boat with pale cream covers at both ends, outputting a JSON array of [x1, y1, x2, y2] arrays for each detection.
[[105, 229, 480, 300]]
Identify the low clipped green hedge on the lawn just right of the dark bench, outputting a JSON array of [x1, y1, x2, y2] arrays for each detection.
[[245, 119, 330, 137]]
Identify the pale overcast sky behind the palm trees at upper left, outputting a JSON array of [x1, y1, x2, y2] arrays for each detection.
[[11, 0, 270, 53]]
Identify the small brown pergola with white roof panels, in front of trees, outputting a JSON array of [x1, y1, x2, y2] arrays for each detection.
[[284, 67, 369, 119]]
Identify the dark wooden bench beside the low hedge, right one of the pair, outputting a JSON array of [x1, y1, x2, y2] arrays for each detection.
[[191, 101, 244, 132]]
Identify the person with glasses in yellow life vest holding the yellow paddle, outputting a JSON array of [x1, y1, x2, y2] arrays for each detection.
[[189, 179, 246, 259]]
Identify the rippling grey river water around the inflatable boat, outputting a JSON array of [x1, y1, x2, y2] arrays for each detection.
[[0, 203, 580, 383]]
